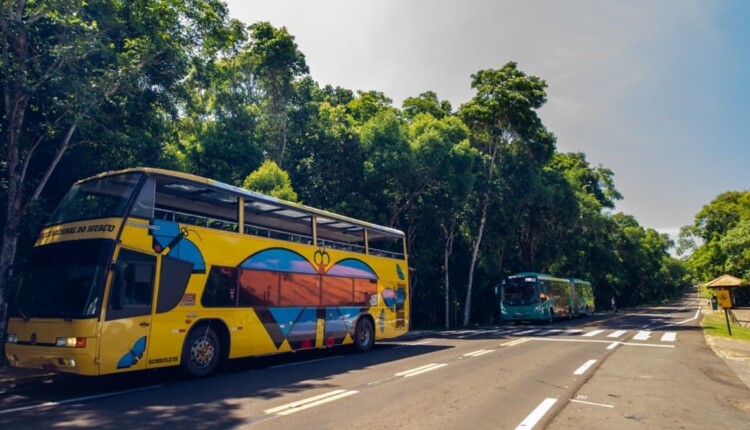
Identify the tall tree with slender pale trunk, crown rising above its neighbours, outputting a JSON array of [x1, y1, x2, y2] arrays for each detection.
[[460, 62, 554, 325]]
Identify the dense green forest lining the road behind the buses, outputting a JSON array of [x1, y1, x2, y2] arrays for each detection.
[[0, 0, 700, 327]]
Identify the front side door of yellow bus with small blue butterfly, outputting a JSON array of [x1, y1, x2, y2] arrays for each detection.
[[99, 249, 156, 374]]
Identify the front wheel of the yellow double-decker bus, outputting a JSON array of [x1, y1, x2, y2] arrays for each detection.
[[180, 325, 221, 378]]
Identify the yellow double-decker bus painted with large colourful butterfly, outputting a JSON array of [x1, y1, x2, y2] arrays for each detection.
[[5, 168, 409, 376]]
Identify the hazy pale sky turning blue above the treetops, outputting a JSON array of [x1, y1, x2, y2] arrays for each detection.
[[226, 0, 750, 237]]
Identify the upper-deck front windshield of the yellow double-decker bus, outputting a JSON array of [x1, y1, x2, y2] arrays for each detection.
[[47, 173, 142, 225]]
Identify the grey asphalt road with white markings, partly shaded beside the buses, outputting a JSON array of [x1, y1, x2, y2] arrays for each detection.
[[0, 297, 750, 430]]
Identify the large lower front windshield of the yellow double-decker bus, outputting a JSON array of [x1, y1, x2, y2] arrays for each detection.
[[10, 240, 114, 320]]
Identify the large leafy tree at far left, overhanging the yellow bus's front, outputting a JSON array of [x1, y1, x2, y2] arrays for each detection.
[[0, 0, 239, 346]]
